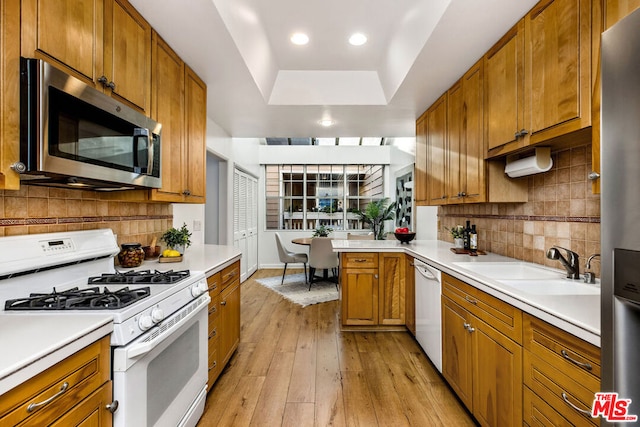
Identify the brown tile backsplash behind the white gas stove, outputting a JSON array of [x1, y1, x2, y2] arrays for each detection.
[[0, 185, 173, 245]]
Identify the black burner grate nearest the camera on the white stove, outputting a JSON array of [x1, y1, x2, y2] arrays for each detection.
[[4, 287, 151, 311]]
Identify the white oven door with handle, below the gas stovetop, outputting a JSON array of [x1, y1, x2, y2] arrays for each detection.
[[113, 294, 211, 427]]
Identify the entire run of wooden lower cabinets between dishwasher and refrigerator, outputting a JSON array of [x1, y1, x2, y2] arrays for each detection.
[[442, 274, 600, 427]]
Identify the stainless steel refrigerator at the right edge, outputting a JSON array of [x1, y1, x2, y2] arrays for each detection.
[[601, 10, 640, 424]]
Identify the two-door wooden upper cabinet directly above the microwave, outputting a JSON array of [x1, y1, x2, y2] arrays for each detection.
[[22, 0, 151, 115]]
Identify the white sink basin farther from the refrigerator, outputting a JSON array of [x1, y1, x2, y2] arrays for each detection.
[[453, 262, 564, 280]]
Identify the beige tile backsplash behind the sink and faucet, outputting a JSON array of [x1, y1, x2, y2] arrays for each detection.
[[438, 144, 600, 277]]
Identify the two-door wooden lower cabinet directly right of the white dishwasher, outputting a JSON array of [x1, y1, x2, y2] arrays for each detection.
[[442, 274, 523, 426]]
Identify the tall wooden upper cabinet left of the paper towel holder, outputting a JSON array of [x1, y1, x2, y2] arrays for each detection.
[[416, 60, 528, 205]]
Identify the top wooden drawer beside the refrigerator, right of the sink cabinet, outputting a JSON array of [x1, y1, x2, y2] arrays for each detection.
[[523, 314, 600, 382]]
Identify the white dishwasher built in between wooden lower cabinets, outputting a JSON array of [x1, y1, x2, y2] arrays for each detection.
[[413, 259, 442, 373]]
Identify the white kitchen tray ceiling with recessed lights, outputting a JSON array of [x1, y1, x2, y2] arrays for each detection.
[[130, 0, 536, 138]]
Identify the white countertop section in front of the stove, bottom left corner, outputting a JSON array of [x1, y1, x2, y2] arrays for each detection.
[[0, 312, 113, 395]]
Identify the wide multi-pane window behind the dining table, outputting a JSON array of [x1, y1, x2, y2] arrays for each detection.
[[265, 165, 384, 230]]
